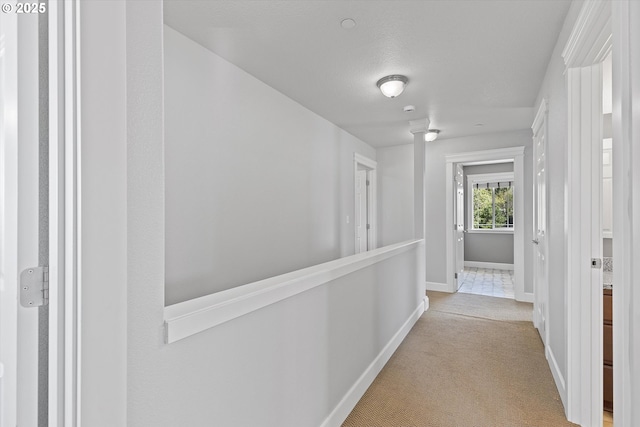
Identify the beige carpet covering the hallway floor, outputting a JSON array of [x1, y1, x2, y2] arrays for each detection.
[[343, 292, 574, 427]]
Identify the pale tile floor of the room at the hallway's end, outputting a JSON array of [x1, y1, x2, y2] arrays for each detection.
[[458, 267, 514, 299]]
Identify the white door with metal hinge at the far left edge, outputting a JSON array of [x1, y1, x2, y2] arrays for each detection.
[[0, 13, 47, 427]]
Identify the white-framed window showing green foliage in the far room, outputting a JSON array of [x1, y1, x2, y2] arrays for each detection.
[[467, 172, 514, 231]]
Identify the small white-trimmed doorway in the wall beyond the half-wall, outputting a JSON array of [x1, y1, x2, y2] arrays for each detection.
[[353, 153, 377, 254]]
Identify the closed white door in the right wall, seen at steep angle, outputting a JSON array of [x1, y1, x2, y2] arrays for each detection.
[[533, 111, 549, 345]]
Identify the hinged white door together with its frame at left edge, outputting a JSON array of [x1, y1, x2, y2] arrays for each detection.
[[0, 2, 80, 426]]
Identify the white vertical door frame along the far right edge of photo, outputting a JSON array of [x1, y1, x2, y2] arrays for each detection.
[[612, 0, 640, 426]]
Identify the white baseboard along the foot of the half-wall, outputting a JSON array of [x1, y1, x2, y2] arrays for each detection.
[[321, 299, 428, 427]]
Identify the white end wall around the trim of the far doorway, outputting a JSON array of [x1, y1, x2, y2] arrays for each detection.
[[425, 130, 533, 293]]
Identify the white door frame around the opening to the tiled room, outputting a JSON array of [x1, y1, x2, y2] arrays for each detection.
[[445, 146, 533, 302]]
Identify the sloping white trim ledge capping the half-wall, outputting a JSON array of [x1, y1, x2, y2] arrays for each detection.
[[164, 240, 424, 344]]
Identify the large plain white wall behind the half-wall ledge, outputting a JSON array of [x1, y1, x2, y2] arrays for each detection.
[[164, 27, 376, 304]]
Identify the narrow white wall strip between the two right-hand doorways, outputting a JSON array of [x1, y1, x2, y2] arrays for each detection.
[[525, 2, 582, 408]]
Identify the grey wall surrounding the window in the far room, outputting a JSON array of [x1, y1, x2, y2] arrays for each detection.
[[464, 163, 513, 264]]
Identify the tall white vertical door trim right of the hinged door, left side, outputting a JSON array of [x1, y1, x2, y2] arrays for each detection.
[[48, 0, 82, 427]]
